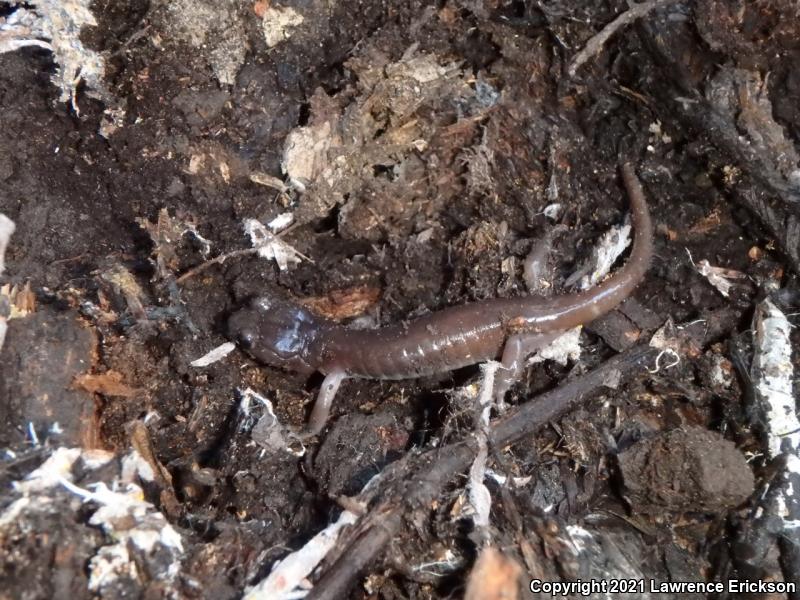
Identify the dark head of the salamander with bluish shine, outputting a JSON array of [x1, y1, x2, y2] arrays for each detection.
[[228, 298, 322, 373]]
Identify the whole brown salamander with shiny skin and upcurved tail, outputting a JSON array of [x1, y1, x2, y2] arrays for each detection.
[[228, 164, 653, 433]]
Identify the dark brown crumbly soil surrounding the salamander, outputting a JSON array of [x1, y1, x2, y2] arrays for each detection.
[[0, 0, 800, 598]]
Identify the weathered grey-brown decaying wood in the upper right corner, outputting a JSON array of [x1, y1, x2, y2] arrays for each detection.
[[639, 8, 800, 272]]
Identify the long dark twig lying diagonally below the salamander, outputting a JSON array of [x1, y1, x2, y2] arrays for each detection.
[[307, 345, 656, 600]]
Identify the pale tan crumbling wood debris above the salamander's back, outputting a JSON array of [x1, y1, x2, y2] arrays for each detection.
[[282, 46, 482, 234]]
